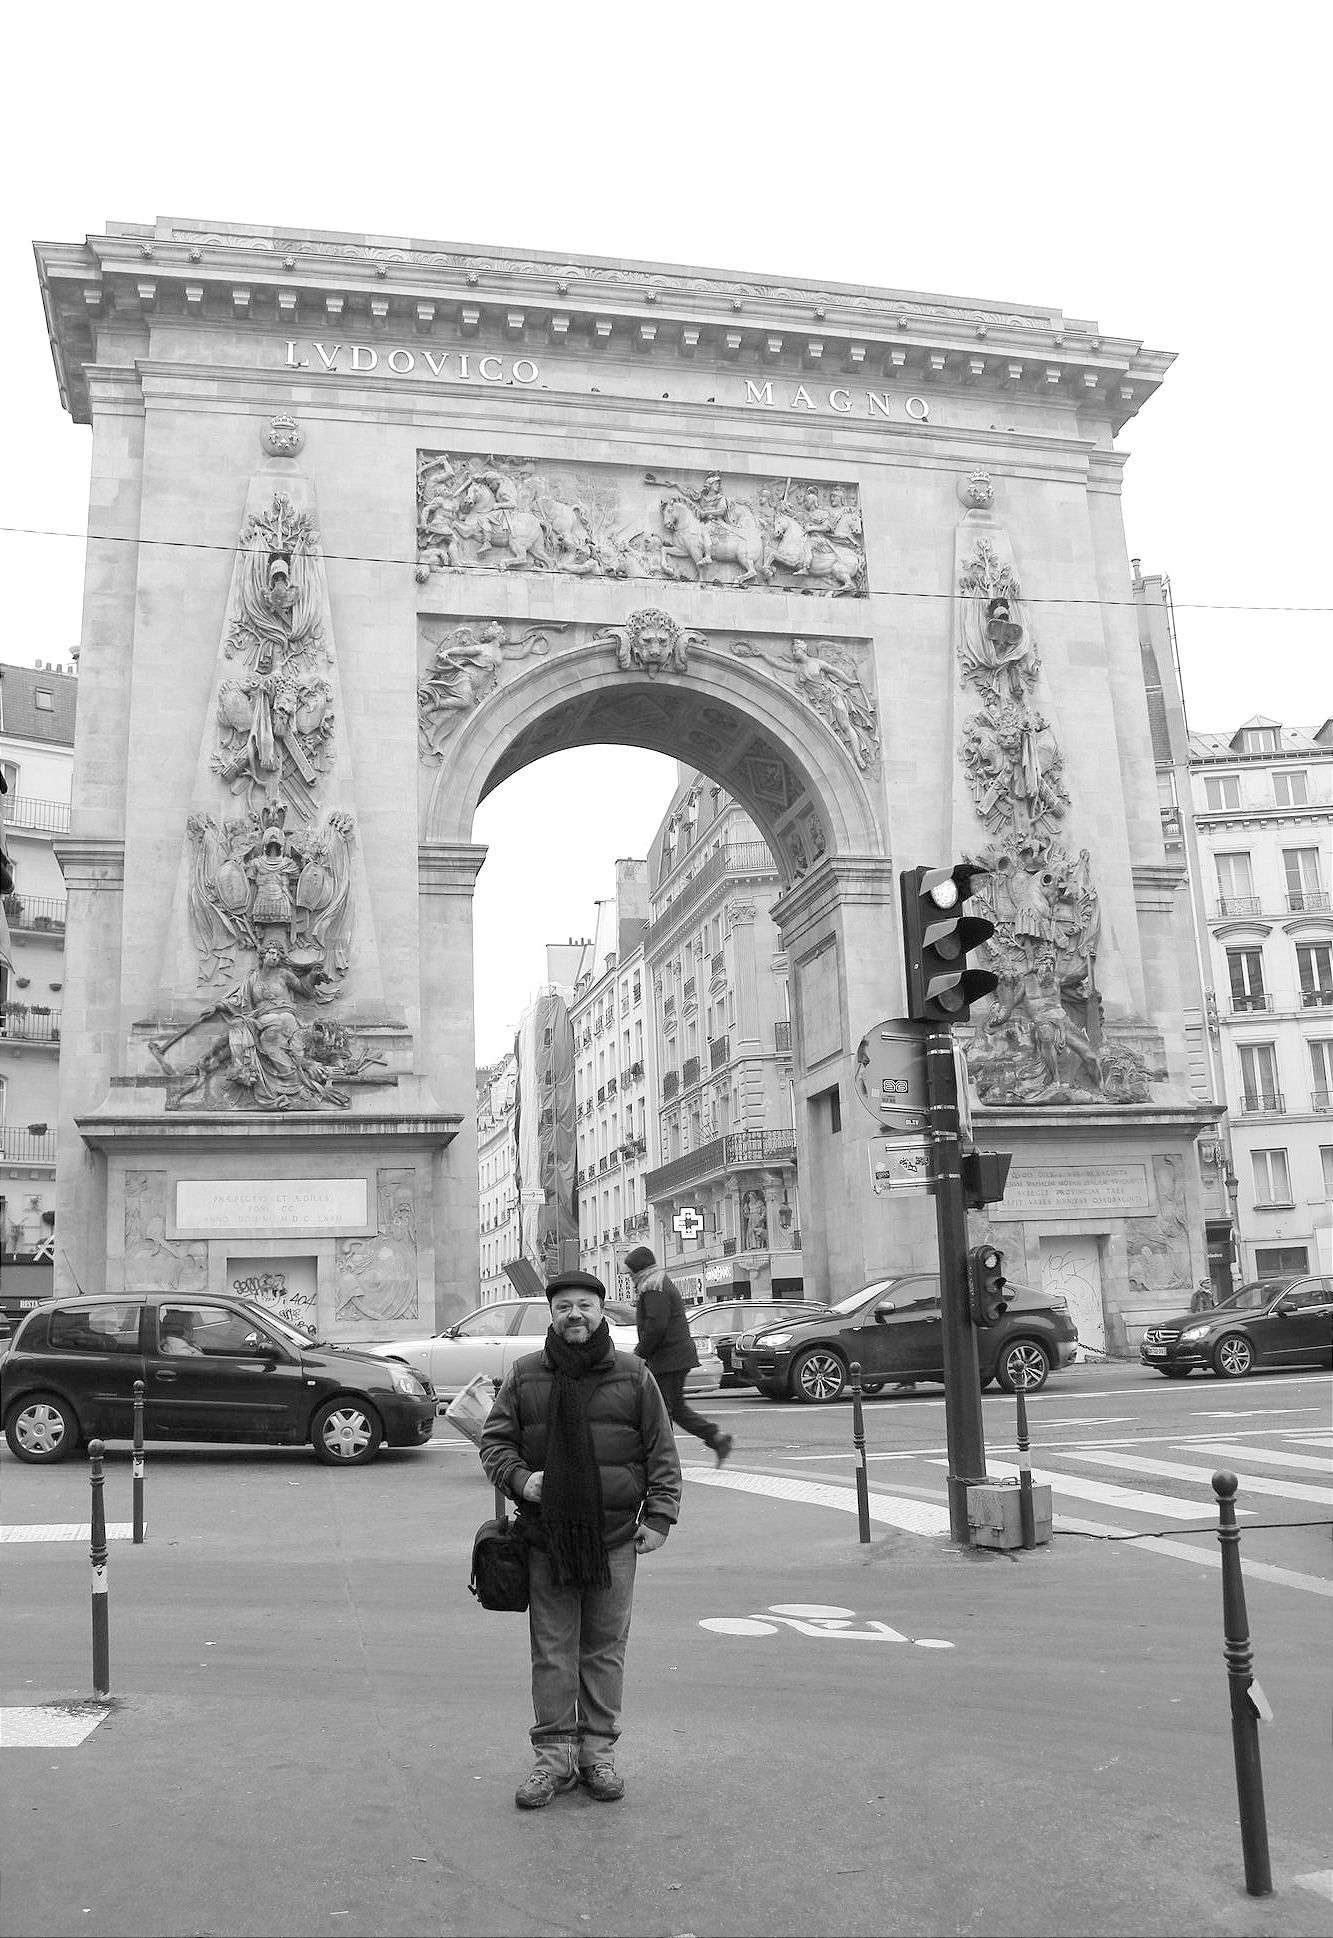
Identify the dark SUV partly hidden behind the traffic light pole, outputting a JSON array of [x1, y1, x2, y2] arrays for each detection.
[[732, 1273, 1079, 1403]]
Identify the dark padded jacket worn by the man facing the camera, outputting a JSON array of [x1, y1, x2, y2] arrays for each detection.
[[479, 1347, 680, 1548]]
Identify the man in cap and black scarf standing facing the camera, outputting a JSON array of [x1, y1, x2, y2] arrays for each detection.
[[481, 1271, 680, 1810]]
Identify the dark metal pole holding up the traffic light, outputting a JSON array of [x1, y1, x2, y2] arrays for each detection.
[[926, 1025, 986, 1547]]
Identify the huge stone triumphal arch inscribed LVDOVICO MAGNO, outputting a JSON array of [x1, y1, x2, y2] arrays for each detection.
[[37, 221, 1209, 1339]]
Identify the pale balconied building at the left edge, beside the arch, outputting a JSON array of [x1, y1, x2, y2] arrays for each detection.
[[0, 665, 78, 1308]]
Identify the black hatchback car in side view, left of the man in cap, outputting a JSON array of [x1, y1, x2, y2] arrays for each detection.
[[0, 1293, 436, 1467]]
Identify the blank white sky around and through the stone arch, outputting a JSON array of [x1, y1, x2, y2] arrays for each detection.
[[0, 0, 1333, 1060]]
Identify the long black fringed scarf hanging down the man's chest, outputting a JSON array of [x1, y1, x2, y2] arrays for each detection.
[[543, 1320, 612, 1587]]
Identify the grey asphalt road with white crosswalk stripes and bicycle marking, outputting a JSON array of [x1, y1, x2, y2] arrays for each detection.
[[0, 1366, 1333, 1938]]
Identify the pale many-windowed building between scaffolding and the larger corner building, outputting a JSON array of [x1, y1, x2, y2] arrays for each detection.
[[570, 860, 661, 1298]]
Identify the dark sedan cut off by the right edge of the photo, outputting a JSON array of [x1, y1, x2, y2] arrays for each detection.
[[1139, 1275, 1333, 1380]]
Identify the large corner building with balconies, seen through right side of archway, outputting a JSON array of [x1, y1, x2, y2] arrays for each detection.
[[643, 767, 806, 1300]]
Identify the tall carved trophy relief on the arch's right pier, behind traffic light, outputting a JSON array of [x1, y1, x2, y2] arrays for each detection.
[[957, 525, 1149, 1105]]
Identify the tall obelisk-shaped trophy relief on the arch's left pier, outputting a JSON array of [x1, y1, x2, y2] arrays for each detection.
[[149, 440, 386, 1110]]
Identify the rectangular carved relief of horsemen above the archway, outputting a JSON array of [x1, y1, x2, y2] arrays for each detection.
[[417, 452, 866, 597]]
